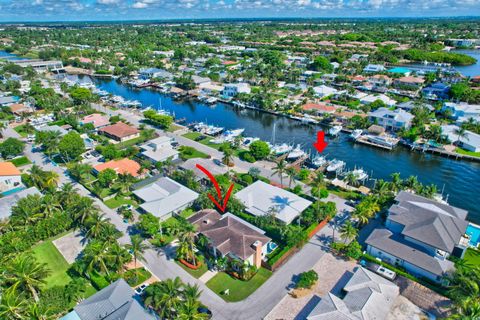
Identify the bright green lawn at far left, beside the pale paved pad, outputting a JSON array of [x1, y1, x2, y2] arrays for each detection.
[[32, 240, 72, 288]]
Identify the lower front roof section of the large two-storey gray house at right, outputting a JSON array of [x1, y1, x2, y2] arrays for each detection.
[[365, 228, 454, 276]]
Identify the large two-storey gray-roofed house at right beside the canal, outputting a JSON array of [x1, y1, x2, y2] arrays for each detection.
[[365, 191, 468, 283]]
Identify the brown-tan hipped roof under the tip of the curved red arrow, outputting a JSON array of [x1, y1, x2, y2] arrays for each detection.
[[188, 209, 271, 260]]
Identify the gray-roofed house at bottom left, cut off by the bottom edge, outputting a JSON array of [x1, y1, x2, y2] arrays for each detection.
[[60, 278, 156, 320]]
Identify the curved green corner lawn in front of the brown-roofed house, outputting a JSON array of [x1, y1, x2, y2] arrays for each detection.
[[207, 268, 272, 302]]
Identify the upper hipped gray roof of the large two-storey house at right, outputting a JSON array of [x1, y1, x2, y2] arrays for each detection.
[[388, 191, 468, 252]]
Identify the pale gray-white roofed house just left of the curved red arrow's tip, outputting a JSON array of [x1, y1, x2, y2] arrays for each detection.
[[133, 177, 199, 221]]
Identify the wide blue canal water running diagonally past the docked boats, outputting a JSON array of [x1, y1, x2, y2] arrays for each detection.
[[95, 80, 480, 223]]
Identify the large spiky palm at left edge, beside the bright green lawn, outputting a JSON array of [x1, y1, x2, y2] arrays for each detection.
[[1, 254, 49, 302]]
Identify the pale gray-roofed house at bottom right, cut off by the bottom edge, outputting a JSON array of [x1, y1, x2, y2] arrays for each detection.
[[307, 267, 400, 320]]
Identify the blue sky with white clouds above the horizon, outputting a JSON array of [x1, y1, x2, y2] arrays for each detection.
[[0, 0, 480, 22]]
